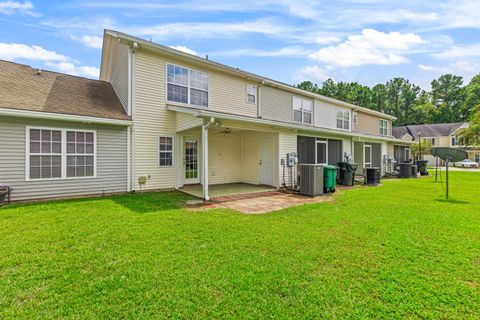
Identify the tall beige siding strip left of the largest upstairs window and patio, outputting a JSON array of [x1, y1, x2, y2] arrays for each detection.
[[133, 50, 178, 190]]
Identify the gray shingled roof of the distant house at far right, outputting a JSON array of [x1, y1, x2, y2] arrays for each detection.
[[393, 122, 464, 140]]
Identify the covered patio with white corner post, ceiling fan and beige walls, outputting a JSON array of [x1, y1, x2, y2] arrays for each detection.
[[175, 113, 279, 200]]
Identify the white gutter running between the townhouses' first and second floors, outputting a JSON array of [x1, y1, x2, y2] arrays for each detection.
[[167, 105, 408, 143]]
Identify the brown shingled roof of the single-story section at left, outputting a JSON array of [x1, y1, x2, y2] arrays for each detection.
[[0, 60, 130, 120]]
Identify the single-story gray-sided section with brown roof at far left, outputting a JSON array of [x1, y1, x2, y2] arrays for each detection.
[[0, 61, 131, 200]]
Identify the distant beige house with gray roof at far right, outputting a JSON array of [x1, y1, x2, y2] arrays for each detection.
[[393, 122, 480, 165]]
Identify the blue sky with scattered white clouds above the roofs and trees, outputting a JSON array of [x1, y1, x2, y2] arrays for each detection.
[[0, 0, 480, 89]]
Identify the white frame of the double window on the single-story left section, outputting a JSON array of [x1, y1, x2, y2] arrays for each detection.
[[25, 126, 97, 181]]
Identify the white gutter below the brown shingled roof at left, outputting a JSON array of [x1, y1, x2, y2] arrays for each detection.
[[0, 108, 132, 126]]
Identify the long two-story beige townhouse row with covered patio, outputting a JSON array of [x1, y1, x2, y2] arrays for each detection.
[[100, 30, 409, 199]]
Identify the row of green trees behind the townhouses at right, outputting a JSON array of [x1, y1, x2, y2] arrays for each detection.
[[296, 74, 480, 126]]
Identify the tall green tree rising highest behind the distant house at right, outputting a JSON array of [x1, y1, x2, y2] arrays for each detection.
[[432, 74, 467, 123]]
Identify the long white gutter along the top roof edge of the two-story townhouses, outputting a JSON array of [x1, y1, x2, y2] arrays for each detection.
[[105, 30, 397, 120]]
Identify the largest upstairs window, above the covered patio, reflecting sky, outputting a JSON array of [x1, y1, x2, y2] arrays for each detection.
[[167, 64, 208, 107]]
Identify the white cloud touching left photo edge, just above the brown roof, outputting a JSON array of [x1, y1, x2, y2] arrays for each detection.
[[0, 43, 68, 61]]
